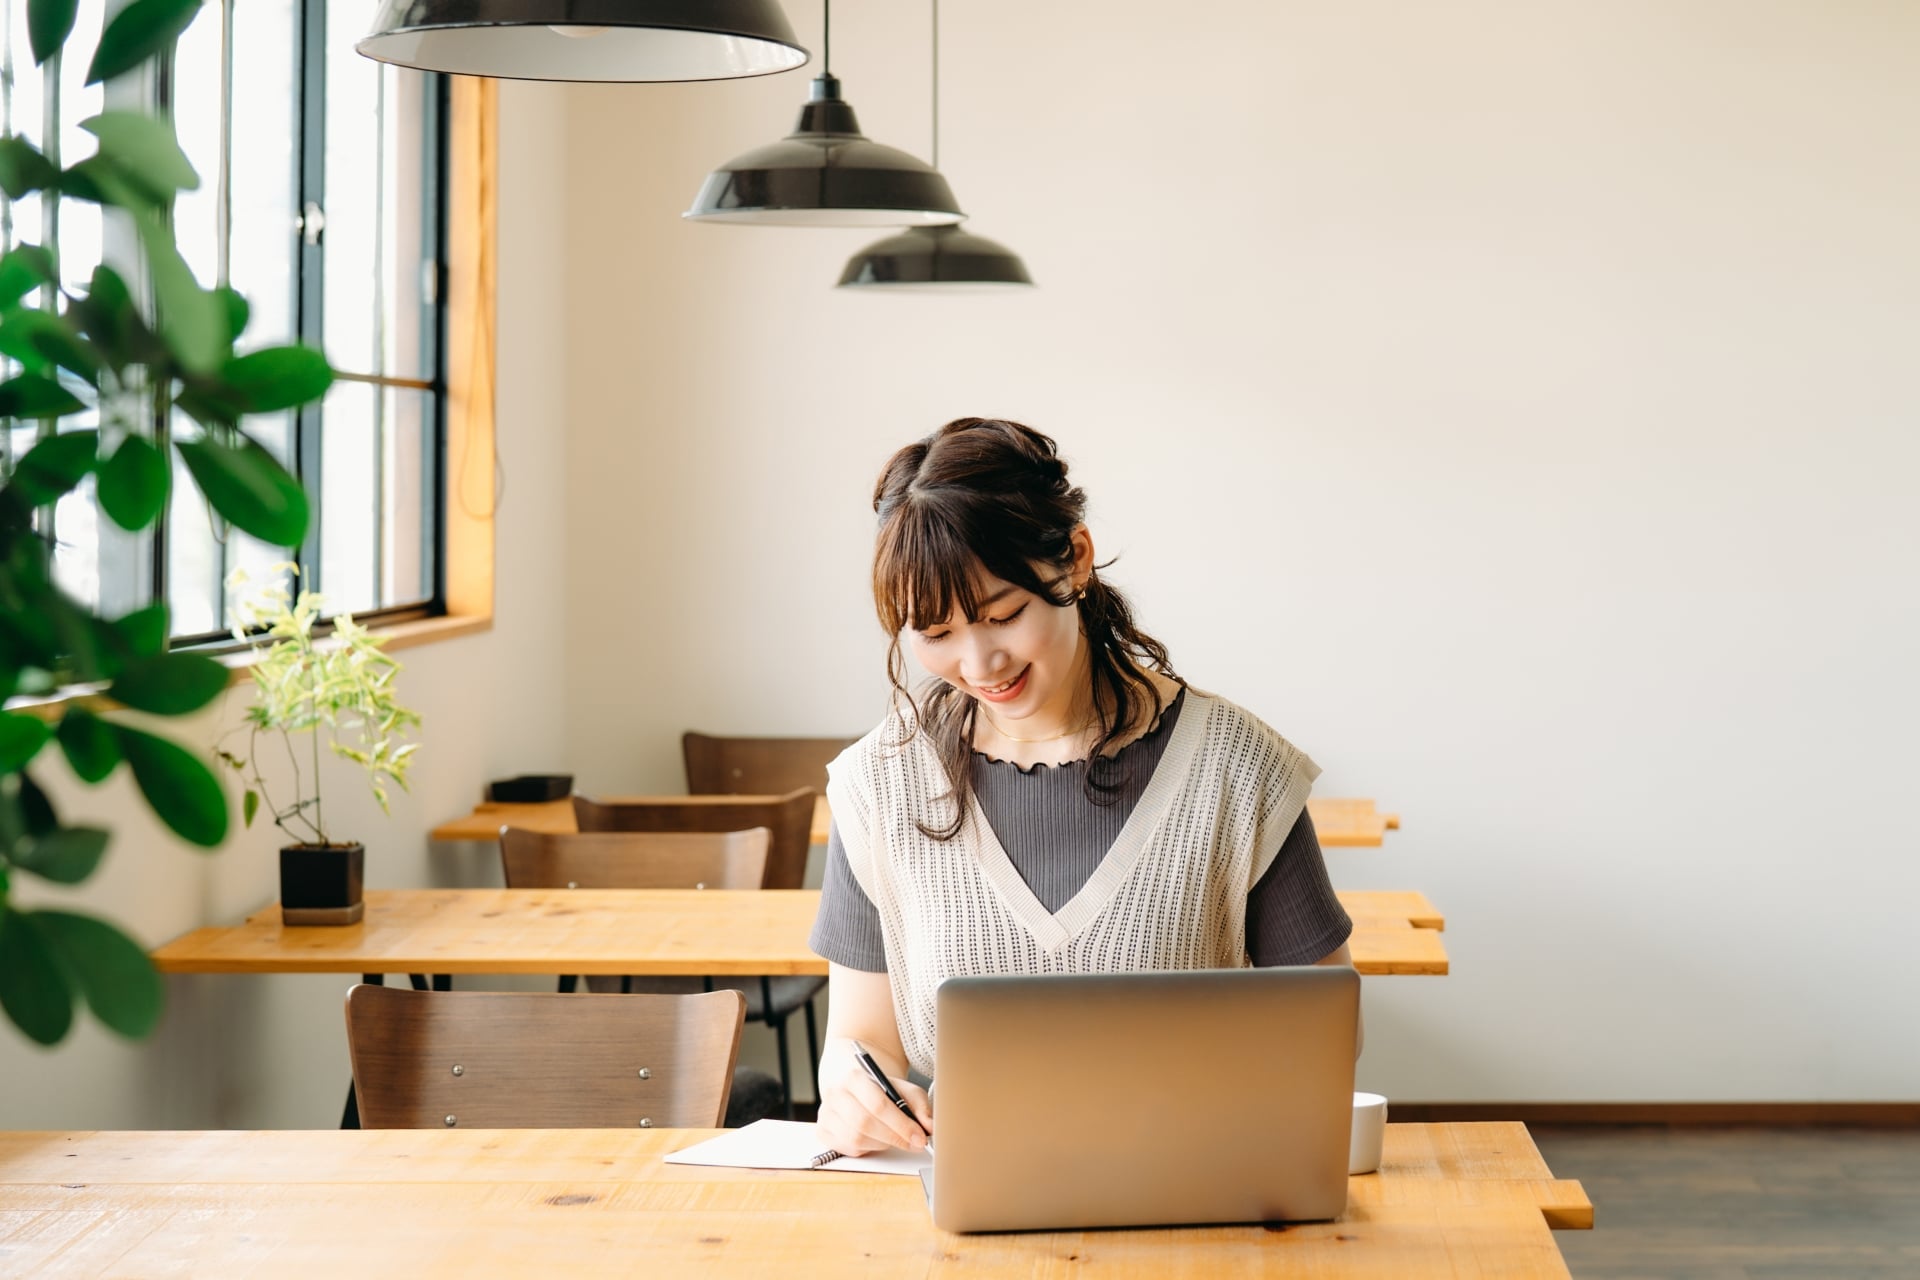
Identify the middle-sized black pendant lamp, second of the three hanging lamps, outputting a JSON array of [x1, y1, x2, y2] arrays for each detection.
[[682, 0, 966, 226]]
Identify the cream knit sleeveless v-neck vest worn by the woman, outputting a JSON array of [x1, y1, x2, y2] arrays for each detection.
[[828, 689, 1319, 1077]]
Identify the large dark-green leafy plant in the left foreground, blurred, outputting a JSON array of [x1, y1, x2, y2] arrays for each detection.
[[0, 0, 332, 1044]]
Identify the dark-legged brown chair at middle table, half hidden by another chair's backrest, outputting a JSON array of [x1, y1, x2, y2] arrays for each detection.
[[574, 787, 828, 1119]]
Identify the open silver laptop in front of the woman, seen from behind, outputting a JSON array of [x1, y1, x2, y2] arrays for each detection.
[[927, 965, 1359, 1232]]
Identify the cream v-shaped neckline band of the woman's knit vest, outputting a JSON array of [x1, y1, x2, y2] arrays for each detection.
[[968, 689, 1212, 954]]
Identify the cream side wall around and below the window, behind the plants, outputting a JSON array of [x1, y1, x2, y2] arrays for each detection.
[[0, 84, 570, 1128]]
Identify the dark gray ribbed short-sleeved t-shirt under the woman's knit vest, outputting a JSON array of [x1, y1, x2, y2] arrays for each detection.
[[808, 689, 1354, 973]]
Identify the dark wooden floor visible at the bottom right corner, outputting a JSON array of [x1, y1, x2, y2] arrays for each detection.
[[1530, 1125, 1920, 1280]]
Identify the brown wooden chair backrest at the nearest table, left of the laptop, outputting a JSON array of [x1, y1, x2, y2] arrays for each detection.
[[348, 983, 747, 1128]]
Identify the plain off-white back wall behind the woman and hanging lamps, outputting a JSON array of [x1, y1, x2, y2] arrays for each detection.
[[560, 0, 1920, 1100]]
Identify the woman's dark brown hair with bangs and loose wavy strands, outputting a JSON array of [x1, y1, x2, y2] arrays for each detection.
[[874, 418, 1177, 841]]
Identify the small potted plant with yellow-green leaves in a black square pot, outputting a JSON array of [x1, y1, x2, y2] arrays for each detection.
[[215, 564, 420, 925]]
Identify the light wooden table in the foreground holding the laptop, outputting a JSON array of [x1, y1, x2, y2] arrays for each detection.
[[0, 1123, 1594, 1280]]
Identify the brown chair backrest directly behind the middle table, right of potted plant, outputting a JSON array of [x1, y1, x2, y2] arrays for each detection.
[[499, 827, 774, 889]]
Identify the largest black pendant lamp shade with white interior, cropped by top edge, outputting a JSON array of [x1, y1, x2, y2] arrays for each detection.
[[353, 0, 806, 81]]
